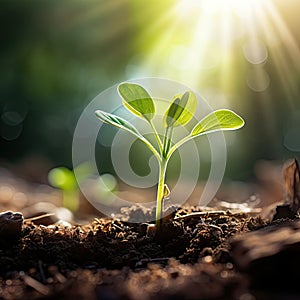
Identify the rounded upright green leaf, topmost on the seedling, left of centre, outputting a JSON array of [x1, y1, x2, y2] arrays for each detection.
[[118, 82, 155, 121]]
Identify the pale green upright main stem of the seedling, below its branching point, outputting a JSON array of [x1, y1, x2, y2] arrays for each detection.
[[156, 159, 168, 230]]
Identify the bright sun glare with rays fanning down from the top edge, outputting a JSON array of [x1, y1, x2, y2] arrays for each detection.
[[128, 0, 300, 112]]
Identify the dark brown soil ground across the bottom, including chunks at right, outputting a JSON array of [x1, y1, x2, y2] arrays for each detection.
[[0, 164, 300, 300]]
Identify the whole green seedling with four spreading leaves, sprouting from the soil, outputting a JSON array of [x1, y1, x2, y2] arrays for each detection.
[[95, 82, 244, 228]]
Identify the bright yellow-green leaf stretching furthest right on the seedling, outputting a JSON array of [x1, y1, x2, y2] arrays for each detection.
[[191, 109, 245, 137]]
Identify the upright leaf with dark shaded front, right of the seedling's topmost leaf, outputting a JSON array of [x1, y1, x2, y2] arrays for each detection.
[[164, 91, 197, 127]]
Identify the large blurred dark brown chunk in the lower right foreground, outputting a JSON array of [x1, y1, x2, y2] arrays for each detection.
[[231, 220, 300, 292]]
